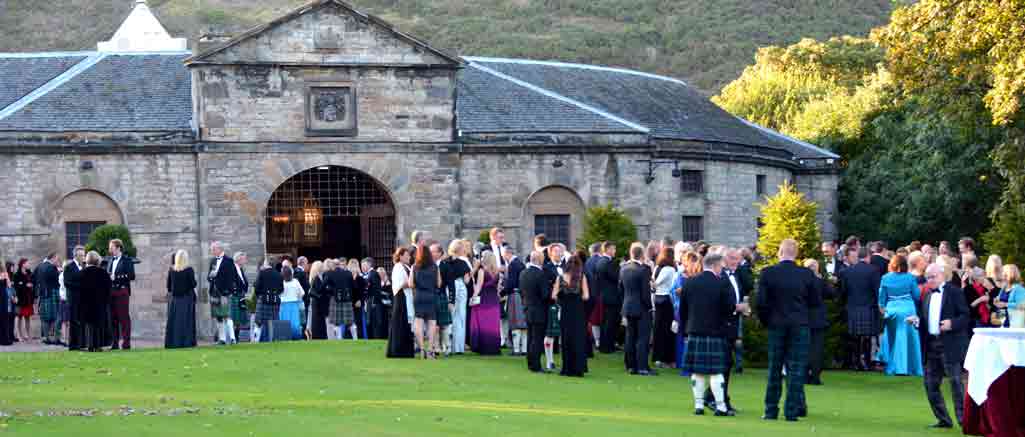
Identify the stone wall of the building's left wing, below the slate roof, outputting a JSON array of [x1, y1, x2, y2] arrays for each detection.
[[0, 154, 199, 337]]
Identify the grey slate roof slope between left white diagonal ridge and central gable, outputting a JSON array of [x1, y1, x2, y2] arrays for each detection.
[[0, 53, 192, 132]]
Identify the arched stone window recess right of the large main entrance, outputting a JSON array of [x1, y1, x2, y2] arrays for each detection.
[[524, 186, 587, 250]]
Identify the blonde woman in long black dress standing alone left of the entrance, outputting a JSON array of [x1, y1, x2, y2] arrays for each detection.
[[164, 250, 196, 349]]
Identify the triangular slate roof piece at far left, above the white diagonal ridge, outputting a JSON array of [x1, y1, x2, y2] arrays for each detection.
[[0, 53, 86, 109]]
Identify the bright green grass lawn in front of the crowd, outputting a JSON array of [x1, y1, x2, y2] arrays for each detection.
[[0, 342, 960, 437]]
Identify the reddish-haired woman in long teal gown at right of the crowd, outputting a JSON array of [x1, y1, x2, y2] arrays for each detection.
[[877, 254, 923, 376]]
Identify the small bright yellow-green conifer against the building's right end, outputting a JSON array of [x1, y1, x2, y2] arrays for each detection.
[[757, 182, 822, 265]]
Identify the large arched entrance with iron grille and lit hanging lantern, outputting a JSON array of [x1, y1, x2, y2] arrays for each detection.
[[265, 165, 396, 267]]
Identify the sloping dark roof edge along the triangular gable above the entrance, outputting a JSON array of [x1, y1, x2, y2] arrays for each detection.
[[186, 0, 463, 66]]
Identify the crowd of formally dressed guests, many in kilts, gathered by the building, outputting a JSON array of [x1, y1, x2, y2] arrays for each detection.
[[0, 228, 1025, 427]]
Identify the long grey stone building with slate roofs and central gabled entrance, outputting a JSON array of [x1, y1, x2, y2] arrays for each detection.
[[0, 0, 838, 336]]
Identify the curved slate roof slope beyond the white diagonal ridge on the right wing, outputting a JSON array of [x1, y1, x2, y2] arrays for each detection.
[[458, 57, 838, 159]]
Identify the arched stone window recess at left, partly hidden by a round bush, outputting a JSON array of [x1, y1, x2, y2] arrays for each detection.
[[51, 189, 124, 260]]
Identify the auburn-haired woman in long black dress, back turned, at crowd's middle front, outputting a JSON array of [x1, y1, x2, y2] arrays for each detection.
[[552, 251, 590, 376]]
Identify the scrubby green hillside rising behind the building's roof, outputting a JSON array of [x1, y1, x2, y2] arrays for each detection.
[[0, 0, 892, 94]]
